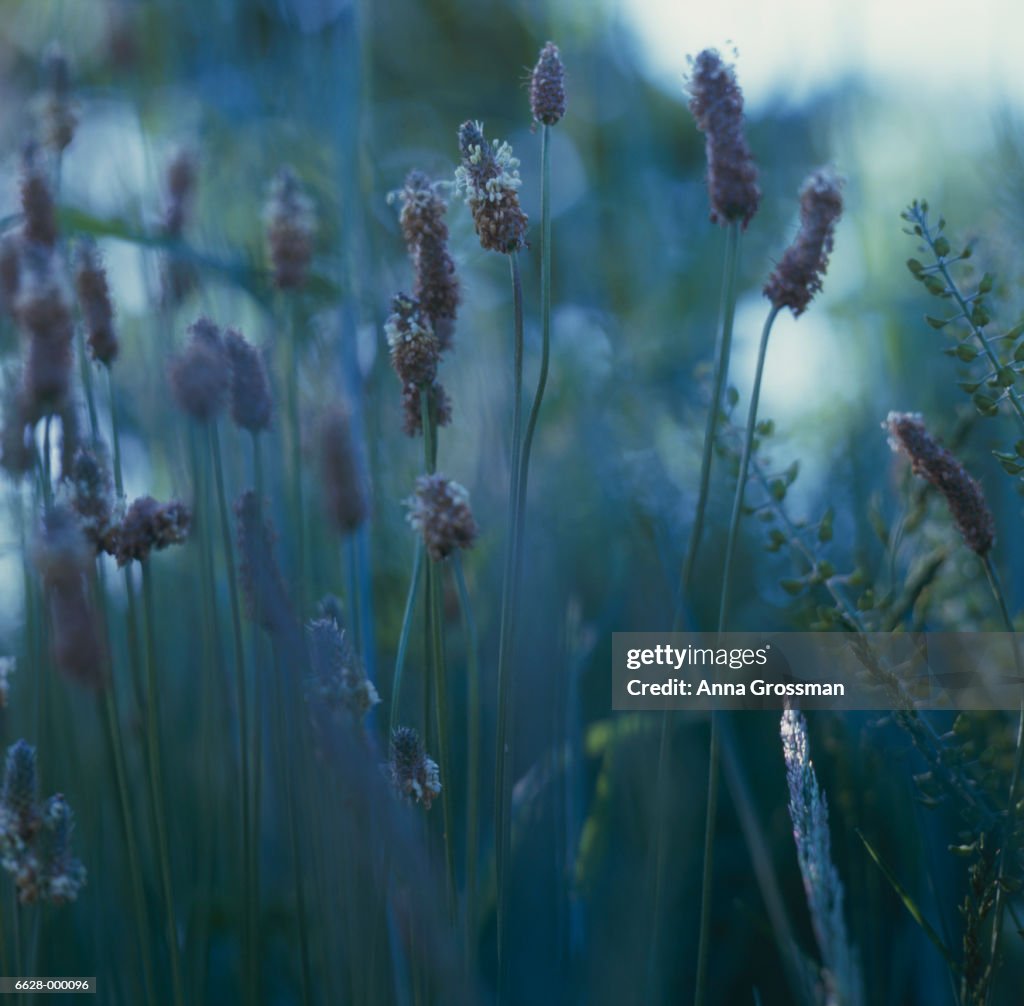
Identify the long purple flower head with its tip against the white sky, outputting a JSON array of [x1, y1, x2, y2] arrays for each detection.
[[689, 49, 761, 229]]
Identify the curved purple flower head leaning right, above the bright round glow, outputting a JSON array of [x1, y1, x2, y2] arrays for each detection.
[[764, 168, 843, 318]]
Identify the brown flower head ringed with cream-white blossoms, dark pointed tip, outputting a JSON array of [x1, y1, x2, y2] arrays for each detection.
[[455, 122, 528, 254]]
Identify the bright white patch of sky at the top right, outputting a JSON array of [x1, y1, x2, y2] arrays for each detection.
[[618, 0, 1024, 111]]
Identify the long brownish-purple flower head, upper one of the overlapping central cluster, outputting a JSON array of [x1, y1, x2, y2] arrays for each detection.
[[389, 171, 459, 352]]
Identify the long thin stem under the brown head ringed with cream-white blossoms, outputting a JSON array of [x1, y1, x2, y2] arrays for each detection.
[[495, 252, 523, 987]]
